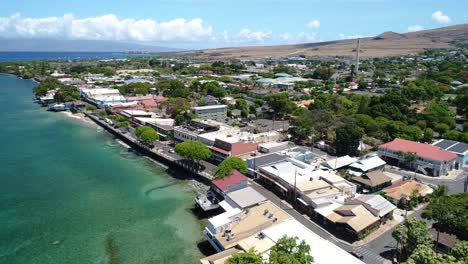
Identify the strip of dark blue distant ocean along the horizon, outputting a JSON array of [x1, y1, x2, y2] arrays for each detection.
[[0, 51, 155, 62]]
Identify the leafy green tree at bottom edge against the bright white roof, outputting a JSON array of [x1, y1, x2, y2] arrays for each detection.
[[270, 236, 314, 264]]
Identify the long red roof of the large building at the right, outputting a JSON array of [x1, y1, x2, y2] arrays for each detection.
[[380, 138, 457, 161]]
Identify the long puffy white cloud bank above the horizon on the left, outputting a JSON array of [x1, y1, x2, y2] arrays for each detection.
[[0, 14, 213, 42]]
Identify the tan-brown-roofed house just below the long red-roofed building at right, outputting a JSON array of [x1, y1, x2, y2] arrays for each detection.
[[383, 180, 433, 205]]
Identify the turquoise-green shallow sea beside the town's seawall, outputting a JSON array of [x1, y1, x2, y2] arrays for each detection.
[[0, 74, 202, 264]]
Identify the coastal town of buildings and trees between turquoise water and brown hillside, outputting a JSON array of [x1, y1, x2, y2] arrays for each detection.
[[0, 41, 468, 264]]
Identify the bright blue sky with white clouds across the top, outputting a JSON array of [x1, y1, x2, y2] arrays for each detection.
[[0, 0, 468, 48]]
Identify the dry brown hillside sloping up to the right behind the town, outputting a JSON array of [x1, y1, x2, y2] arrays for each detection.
[[177, 24, 468, 60]]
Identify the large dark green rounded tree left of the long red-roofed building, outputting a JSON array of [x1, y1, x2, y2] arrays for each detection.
[[335, 122, 363, 156]]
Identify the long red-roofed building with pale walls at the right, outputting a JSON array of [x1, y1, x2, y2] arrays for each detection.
[[379, 138, 458, 176]]
